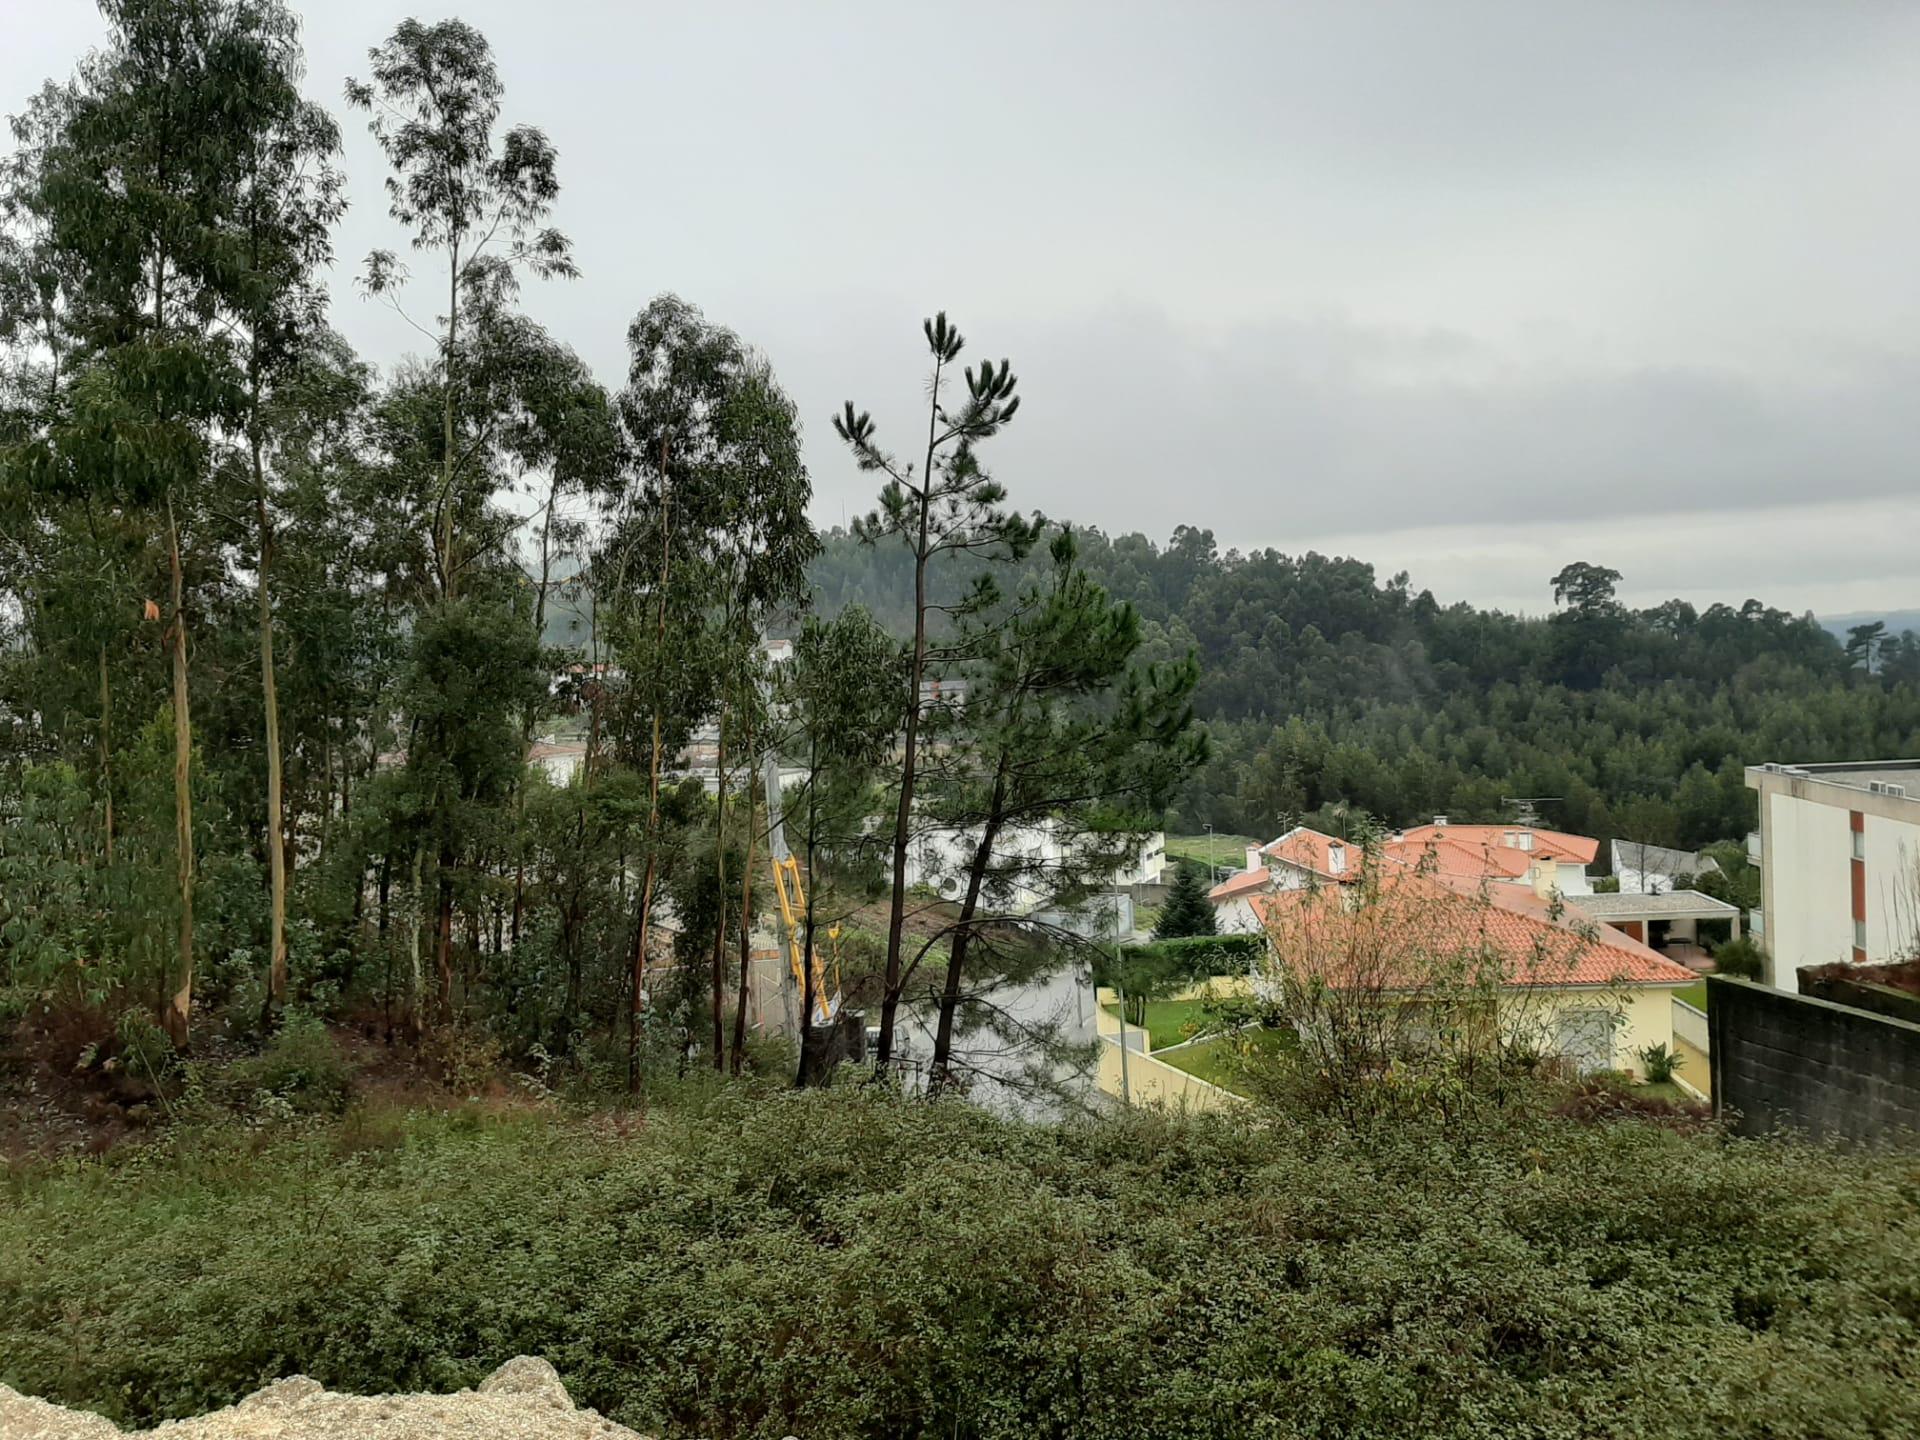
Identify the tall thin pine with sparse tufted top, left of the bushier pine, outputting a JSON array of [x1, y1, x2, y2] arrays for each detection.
[[833, 311, 1041, 1069]]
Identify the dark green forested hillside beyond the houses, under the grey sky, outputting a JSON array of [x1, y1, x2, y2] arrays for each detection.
[[812, 526, 1920, 847]]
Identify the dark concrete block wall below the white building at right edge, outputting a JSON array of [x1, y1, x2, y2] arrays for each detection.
[[1707, 975, 1920, 1140]]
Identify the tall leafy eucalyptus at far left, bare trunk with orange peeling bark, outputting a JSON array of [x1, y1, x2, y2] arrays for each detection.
[[19, 0, 326, 1043]]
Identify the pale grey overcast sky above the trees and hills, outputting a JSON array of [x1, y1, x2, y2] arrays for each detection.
[[0, 0, 1920, 612]]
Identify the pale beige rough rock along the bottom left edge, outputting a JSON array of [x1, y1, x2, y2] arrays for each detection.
[[0, 1356, 643, 1440]]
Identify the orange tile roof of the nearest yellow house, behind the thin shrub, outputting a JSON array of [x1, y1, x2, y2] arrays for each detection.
[[1254, 870, 1695, 989]]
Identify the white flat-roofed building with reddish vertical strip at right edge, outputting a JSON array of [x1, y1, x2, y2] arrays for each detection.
[[1747, 760, 1920, 991]]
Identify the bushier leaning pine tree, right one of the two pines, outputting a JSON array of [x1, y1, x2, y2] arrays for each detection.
[[908, 530, 1206, 1091]]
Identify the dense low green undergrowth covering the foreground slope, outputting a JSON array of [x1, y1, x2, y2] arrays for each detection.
[[11, 1089, 1920, 1440]]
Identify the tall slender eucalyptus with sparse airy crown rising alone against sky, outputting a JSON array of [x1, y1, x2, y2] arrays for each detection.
[[346, 19, 576, 599]]
